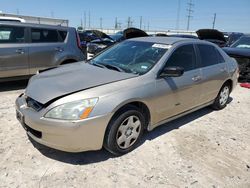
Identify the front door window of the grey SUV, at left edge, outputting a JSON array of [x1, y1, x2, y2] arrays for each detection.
[[0, 26, 24, 43]]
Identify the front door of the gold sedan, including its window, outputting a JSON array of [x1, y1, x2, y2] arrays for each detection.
[[156, 44, 201, 121]]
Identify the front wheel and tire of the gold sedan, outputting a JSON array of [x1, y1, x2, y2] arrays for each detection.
[[104, 106, 145, 156]]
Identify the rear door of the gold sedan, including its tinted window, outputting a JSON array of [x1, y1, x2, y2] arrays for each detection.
[[196, 44, 228, 103]]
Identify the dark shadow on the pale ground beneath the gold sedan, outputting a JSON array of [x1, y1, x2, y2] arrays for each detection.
[[29, 97, 233, 165]]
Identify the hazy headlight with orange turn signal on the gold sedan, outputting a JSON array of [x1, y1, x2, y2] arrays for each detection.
[[44, 98, 98, 120]]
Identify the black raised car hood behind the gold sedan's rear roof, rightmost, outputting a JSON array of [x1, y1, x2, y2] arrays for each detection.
[[196, 29, 226, 42]]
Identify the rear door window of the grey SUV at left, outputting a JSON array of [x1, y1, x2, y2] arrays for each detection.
[[31, 28, 60, 43]]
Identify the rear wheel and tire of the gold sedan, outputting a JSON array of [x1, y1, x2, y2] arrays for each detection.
[[212, 83, 231, 110]]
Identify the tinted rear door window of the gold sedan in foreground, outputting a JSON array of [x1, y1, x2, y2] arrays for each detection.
[[198, 44, 225, 67]]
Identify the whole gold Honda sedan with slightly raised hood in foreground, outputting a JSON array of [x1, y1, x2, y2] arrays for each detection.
[[16, 37, 238, 155]]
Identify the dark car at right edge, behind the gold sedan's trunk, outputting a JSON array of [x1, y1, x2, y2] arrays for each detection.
[[223, 35, 250, 82]]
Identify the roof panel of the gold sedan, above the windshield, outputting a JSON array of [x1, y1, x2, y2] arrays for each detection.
[[129, 37, 210, 45]]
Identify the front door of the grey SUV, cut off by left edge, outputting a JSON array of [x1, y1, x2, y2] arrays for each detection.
[[0, 25, 29, 78]]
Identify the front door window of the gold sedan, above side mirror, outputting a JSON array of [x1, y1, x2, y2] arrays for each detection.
[[166, 44, 196, 71]]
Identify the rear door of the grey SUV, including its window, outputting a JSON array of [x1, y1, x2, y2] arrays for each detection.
[[29, 28, 65, 74]]
